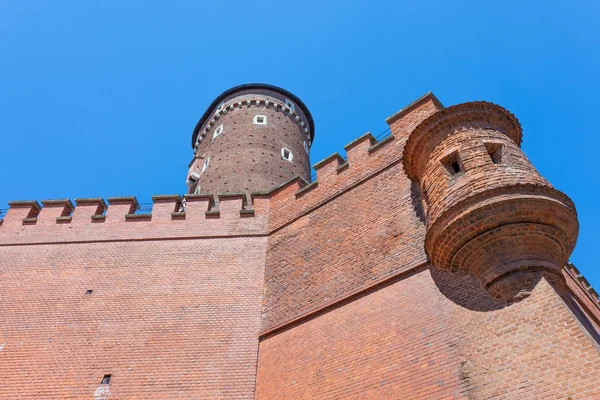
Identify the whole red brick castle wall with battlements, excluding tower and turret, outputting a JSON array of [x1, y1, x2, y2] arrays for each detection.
[[0, 89, 600, 400]]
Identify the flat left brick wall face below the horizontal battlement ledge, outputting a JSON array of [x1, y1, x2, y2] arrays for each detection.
[[0, 236, 266, 399]]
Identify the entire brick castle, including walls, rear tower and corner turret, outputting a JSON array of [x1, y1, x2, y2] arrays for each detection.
[[0, 89, 600, 400]]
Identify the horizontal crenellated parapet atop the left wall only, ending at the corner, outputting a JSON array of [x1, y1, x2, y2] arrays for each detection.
[[0, 194, 267, 245]]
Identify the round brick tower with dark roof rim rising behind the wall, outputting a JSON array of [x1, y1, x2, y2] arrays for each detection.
[[187, 84, 314, 194]]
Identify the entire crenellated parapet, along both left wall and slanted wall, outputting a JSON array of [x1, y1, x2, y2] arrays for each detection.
[[0, 93, 441, 244]]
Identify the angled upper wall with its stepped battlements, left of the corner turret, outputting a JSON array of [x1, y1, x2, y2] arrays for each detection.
[[263, 96, 446, 332]]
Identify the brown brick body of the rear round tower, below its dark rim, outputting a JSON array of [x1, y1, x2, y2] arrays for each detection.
[[188, 93, 310, 194]]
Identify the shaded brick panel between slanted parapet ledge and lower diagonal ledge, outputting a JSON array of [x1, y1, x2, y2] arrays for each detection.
[[263, 164, 426, 330]]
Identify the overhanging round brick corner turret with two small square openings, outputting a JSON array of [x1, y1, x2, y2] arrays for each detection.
[[403, 102, 579, 301]]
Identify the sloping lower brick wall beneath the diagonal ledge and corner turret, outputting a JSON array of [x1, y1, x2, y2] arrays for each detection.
[[257, 269, 600, 399]]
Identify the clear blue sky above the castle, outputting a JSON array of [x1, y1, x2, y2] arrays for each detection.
[[0, 0, 600, 290]]
